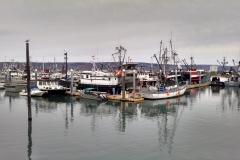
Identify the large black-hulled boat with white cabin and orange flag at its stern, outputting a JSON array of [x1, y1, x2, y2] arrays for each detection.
[[77, 46, 139, 94]]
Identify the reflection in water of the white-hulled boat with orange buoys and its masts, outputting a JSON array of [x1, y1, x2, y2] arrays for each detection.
[[139, 95, 188, 153]]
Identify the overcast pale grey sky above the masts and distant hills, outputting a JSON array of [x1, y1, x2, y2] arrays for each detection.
[[0, 0, 240, 65]]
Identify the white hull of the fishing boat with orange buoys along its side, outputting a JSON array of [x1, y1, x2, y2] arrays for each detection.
[[140, 81, 187, 100]]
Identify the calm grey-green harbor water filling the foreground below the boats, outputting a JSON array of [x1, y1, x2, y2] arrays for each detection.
[[0, 87, 240, 160]]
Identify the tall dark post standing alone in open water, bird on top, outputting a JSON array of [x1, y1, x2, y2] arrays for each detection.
[[25, 40, 32, 121]]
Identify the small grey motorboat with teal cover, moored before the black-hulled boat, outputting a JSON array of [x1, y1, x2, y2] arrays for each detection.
[[78, 88, 107, 100]]
